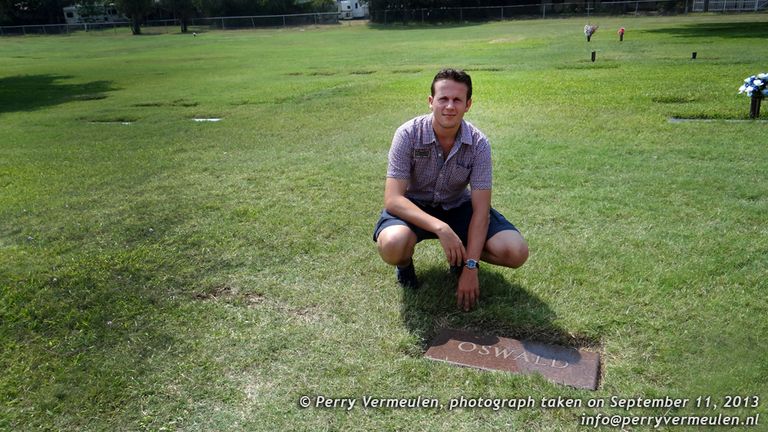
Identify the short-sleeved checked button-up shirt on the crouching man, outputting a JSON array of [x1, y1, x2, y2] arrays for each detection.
[[387, 114, 492, 210]]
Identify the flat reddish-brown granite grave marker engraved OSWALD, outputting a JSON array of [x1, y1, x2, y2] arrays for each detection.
[[425, 329, 600, 390]]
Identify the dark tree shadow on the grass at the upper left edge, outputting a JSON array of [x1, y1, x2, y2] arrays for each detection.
[[0, 74, 115, 114]]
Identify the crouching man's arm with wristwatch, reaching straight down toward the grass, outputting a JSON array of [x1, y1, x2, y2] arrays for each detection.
[[456, 189, 491, 311]]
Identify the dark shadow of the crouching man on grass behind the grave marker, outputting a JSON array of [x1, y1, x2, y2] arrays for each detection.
[[401, 266, 600, 352]]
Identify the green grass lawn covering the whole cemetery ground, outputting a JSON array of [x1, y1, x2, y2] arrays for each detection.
[[0, 14, 768, 431]]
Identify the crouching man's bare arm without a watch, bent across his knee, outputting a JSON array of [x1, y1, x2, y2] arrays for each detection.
[[384, 177, 468, 266]]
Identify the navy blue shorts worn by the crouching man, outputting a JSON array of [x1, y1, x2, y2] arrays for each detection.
[[373, 201, 519, 246]]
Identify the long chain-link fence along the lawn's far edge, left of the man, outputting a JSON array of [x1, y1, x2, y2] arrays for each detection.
[[0, 12, 339, 36]]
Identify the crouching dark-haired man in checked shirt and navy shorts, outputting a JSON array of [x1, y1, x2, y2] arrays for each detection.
[[373, 69, 528, 311]]
